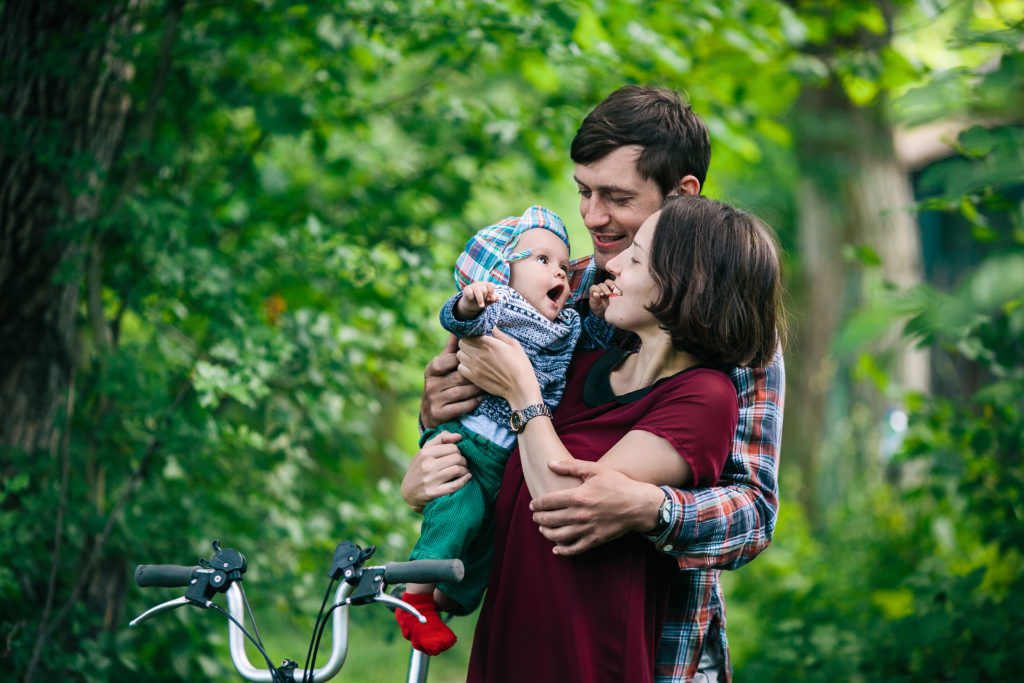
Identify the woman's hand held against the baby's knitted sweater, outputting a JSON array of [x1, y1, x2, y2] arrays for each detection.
[[457, 328, 542, 409]]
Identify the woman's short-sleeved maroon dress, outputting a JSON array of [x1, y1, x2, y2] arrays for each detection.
[[467, 351, 737, 683]]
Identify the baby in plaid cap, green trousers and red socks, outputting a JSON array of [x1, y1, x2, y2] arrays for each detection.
[[395, 206, 581, 654]]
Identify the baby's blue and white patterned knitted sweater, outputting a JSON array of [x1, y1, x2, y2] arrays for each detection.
[[440, 285, 581, 435]]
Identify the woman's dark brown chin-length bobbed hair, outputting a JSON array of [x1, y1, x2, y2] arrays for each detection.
[[647, 196, 785, 368]]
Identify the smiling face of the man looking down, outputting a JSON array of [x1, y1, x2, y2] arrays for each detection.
[[573, 144, 664, 270]]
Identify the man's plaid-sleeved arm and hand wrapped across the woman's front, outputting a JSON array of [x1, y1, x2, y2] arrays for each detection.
[[531, 352, 785, 569]]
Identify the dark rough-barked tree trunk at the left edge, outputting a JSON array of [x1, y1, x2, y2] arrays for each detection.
[[0, 0, 130, 452]]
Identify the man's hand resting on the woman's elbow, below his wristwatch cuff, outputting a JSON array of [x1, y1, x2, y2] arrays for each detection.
[[529, 460, 665, 555]]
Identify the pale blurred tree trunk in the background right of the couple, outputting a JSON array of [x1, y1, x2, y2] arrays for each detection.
[[782, 82, 928, 520]]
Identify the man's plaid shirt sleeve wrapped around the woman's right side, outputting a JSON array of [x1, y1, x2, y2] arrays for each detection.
[[655, 350, 785, 569]]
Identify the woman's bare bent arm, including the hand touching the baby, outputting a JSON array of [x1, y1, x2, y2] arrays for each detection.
[[459, 329, 693, 498]]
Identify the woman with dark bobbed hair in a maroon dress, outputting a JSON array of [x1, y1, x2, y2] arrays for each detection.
[[417, 197, 780, 682]]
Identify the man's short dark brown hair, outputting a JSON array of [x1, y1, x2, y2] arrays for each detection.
[[569, 85, 711, 197]]
